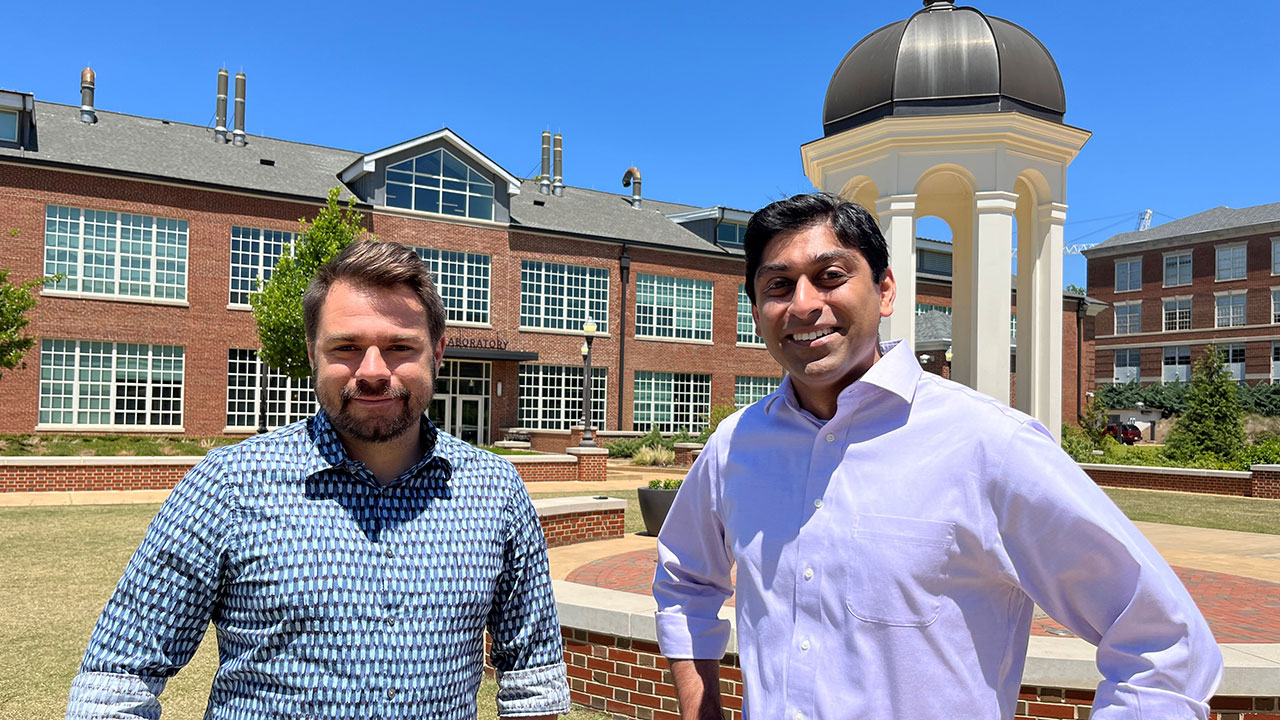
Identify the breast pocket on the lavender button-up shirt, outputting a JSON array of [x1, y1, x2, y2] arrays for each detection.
[[845, 514, 955, 628]]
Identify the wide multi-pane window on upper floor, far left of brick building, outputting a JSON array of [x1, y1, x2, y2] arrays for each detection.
[[45, 205, 187, 300]]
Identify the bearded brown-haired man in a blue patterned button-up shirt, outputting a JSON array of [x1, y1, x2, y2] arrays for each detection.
[[67, 242, 568, 720]]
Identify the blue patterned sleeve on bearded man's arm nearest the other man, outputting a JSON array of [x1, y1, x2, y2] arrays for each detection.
[[488, 479, 570, 717]]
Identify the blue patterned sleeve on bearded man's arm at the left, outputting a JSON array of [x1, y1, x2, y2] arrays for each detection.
[[67, 454, 234, 720]]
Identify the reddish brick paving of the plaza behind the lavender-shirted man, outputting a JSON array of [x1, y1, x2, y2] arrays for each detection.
[[566, 550, 1280, 643]]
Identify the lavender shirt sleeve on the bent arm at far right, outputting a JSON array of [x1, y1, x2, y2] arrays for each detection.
[[993, 423, 1222, 720]]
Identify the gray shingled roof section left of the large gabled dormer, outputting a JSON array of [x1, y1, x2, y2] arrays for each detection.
[[0, 100, 361, 200]]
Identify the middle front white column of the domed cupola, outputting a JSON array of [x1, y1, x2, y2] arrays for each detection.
[[970, 191, 1018, 404]]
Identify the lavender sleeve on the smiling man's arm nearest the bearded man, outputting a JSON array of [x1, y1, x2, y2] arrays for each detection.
[[653, 436, 733, 660]]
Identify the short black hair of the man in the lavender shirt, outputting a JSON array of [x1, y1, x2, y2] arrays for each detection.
[[742, 192, 888, 305]]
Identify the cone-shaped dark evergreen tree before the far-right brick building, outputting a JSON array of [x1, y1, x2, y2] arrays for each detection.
[[1165, 346, 1244, 462]]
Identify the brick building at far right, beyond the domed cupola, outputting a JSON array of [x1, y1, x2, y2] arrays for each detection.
[[1084, 204, 1280, 384]]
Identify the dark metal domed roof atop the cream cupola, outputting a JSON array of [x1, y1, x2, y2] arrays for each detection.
[[822, 0, 1066, 136]]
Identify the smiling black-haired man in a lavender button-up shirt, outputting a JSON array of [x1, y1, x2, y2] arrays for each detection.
[[653, 195, 1222, 720]]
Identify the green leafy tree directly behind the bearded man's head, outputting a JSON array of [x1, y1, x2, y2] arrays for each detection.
[[248, 187, 366, 379]]
